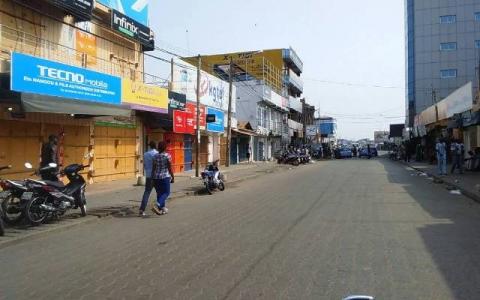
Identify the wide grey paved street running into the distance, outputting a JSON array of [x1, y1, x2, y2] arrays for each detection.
[[0, 160, 480, 299]]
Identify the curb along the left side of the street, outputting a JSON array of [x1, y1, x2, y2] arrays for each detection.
[[0, 168, 288, 249]]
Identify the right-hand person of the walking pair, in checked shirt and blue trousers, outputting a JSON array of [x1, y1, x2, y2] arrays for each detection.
[[152, 142, 175, 215]]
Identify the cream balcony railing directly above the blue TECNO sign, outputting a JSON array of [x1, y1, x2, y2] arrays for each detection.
[[0, 24, 168, 86]]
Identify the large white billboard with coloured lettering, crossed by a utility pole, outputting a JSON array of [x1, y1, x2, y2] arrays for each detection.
[[172, 60, 237, 112]]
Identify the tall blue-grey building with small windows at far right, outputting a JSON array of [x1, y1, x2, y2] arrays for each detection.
[[405, 0, 480, 127]]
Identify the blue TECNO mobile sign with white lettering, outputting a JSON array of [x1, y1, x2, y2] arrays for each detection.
[[10, 52, 122, 104]]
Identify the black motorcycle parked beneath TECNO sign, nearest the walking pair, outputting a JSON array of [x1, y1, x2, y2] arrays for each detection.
[[22, 164, 88, 225]]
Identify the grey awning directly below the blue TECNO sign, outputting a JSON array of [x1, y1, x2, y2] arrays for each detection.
[[20, 93, 131, 117]]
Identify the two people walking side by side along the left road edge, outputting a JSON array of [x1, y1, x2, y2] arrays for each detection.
[[139, 141, 175, 217]]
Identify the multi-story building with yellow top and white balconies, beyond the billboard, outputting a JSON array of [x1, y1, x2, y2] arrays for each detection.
[[184, 48, 303, 160]]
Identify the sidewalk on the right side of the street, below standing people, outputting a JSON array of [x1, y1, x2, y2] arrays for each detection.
[[407, 162, 480, 202]]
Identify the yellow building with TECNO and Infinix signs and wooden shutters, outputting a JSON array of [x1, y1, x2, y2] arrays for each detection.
[[0, 0, 168, 182]]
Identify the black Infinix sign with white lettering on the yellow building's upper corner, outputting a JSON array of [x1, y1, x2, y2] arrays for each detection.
[[112, 9, 153, 48]]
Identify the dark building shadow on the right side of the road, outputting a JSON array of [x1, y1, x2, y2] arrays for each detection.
[[379, 159, 480, 299]]
